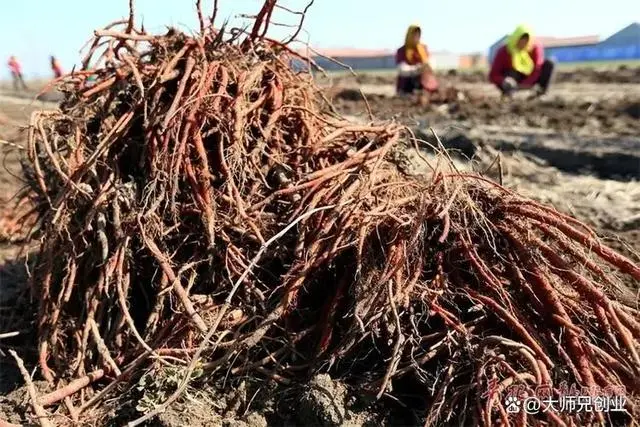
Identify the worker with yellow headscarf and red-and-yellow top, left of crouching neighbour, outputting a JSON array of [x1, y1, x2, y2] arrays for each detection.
[[396, 25, 438, 94]]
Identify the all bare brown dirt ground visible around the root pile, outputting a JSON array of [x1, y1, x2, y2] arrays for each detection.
[[0, 68, 640, 427]]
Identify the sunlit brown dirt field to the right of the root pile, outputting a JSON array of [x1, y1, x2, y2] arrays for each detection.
[[330, 81, 640, 280]]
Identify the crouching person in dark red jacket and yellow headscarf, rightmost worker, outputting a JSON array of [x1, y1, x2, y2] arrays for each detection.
[[489, 25, 553, 97]]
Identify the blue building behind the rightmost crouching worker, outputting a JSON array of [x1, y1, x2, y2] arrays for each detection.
[[488, 22, 640, 63]]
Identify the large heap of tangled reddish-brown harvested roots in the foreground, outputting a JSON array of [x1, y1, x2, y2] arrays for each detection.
[[7, 0, 640, 425]]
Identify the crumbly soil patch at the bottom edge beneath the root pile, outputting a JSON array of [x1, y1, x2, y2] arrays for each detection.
[[108, 374, 421, 427]]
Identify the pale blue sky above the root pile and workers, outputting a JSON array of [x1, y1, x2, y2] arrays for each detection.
[[0, 0, 640, 78]]
